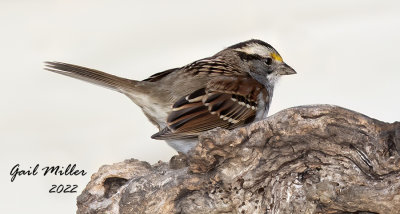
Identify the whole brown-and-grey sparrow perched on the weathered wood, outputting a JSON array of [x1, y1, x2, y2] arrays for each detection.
[[45, 39, 296, 154]]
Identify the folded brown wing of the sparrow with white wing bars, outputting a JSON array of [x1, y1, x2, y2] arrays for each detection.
[[152, 77, 266, 139]]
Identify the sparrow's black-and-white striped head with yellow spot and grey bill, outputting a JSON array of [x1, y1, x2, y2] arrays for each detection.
[[224, 39, 296, 87]]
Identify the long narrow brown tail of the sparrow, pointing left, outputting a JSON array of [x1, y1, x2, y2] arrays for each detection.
[[45, 62, 138, 93]]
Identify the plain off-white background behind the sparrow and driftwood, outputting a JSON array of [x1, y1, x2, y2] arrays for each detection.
[[0, 0, 400, 213]]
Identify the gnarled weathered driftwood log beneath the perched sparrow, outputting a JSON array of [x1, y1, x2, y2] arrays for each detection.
[[77, 105, 400, 214]]
